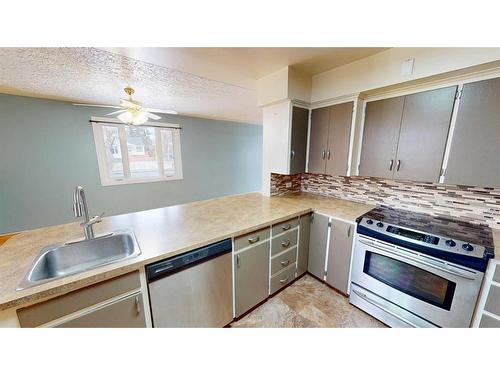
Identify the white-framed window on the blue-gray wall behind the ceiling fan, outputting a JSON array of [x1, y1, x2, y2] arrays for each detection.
[[92, 119, 182, 186]]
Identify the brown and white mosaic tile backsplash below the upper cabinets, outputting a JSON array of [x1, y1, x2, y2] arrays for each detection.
[[271, 173, 500, 229]]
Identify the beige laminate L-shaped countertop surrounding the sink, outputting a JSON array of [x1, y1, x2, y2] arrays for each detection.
[[0, 193, 373, 311]]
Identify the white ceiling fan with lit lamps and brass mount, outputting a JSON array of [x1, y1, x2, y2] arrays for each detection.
[[73, 87, 177, 125]]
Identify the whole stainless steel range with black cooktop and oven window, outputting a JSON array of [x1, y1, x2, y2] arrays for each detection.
[[349, 208, 494, 327]]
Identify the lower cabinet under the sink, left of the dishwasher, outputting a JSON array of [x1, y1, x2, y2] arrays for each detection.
[[17, 272, 146, 328]]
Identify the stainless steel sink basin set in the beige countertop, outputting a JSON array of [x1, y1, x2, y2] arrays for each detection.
[[16, 230, 141, 290]]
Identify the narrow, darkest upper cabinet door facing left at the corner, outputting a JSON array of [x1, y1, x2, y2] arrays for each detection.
[[290, 107, 309, 174]]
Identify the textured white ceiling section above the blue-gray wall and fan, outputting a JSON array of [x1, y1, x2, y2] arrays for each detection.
[[0, 48, 262, 123]]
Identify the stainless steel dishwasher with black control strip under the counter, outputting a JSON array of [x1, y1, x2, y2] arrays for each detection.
[[146, 239, 233, 327]]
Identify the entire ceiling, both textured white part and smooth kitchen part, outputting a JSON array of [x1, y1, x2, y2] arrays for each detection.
[[0, 48, 383, 123]]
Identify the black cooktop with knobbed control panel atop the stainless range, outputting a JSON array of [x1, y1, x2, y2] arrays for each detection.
[[358, 207, 494, 271]]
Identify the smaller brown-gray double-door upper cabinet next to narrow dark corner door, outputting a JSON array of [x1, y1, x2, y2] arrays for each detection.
[[308, 102, 354, 176]]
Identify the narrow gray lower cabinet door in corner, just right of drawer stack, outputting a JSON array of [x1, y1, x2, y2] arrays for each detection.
[[307, 213, 329, 280]]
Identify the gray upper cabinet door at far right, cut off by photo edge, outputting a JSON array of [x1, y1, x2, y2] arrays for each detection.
[[444, 78, 500, 187]]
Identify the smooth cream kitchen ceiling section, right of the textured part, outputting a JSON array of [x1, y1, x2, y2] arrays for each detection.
[[103, 47, 387, 89]]
